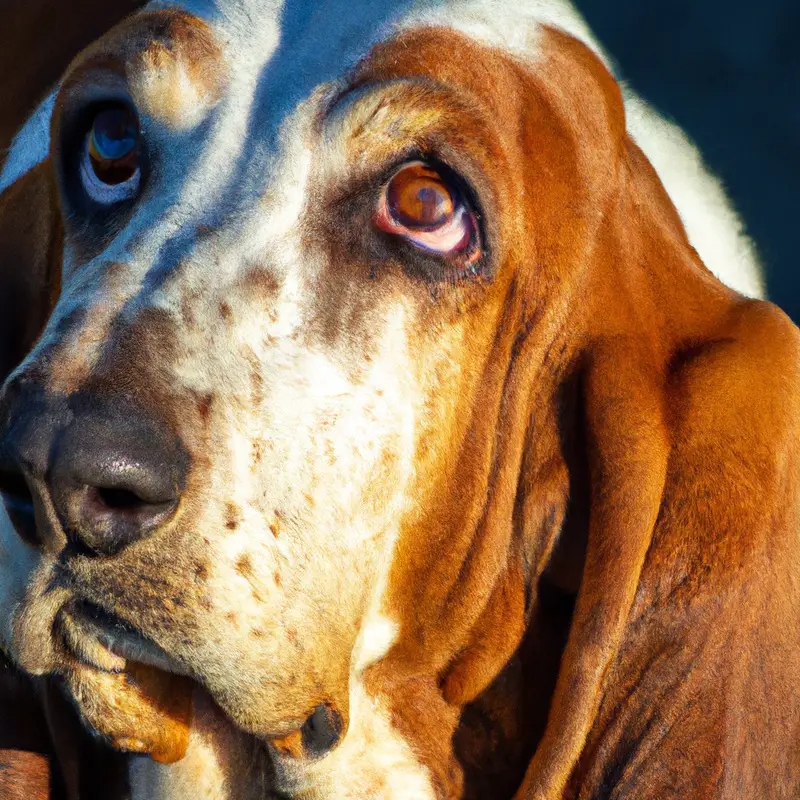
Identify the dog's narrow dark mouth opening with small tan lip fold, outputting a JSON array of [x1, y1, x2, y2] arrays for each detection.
[[58, 601, 190, 676]]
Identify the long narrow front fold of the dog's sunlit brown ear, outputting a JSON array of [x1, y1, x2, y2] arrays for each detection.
[[517, 337, 669, 800]]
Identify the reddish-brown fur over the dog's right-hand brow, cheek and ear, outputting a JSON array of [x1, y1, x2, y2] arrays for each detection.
[[0, 6, 800, 800]]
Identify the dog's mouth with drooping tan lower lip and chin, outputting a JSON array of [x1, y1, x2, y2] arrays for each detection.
[[55, 601, 197, 763]]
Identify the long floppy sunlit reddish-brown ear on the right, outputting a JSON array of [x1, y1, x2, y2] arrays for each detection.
[[516, 106, 800, 800]]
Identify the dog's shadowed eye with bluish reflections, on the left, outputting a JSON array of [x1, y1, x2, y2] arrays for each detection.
[[80, 105, 141, 205]]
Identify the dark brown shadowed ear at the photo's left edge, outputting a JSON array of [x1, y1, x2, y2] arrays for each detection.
[[0, 159, 62, 380]]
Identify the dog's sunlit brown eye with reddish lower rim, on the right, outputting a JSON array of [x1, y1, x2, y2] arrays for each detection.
[[375, 161, 480, 263]]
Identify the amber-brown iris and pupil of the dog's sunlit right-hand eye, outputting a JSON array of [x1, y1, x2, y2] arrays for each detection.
[[386, 164, 456, 228]]
